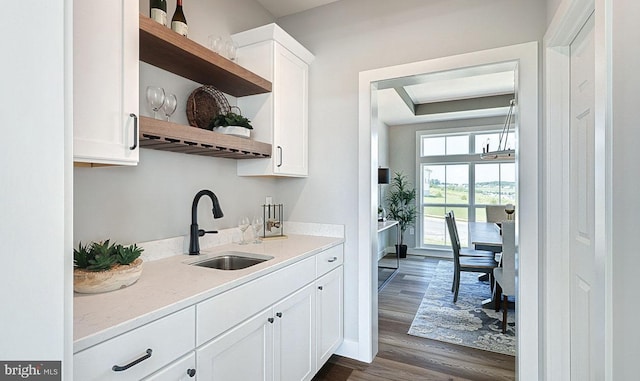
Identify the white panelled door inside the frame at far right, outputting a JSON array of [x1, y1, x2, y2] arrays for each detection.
[[569, 15, 605, 381]]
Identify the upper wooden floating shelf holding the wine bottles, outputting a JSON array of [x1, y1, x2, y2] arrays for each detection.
[[140, 14, 271, 97]]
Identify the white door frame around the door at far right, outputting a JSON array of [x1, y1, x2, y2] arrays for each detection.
[[541, 0, 613, 380]]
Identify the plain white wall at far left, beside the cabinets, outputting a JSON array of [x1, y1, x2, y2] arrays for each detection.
[[0, 0, 71, 372]]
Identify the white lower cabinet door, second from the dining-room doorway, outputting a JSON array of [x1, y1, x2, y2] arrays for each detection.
[[273, 284, 316, 381]]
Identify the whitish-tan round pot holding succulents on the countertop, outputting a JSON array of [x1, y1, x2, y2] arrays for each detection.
[[73, 258, 142, 294]]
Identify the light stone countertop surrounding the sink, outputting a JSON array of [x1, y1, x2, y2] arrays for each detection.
[[73, 235, 344, 353]]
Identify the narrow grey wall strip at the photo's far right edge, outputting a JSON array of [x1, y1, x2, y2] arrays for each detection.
[[606, 0, 640, 380]]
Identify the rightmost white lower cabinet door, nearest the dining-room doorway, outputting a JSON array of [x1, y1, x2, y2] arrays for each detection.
[[316, 266, 343, 369]]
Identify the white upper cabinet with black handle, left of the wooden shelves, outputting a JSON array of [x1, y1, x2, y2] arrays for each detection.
[[73, 0, 139, 165]]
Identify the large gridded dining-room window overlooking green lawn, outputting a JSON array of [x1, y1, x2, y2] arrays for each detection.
[[417, 126, 516, 248]]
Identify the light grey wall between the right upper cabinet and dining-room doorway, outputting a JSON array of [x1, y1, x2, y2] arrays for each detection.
[[278, 0, 546, 356]]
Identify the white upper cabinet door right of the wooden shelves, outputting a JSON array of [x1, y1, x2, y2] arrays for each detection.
[[273, 43, 309, 176]]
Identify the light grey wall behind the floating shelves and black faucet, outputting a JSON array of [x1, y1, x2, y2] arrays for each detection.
[[74, 0, 278, 244]]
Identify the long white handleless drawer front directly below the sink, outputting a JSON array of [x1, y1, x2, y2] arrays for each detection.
[[196, 257, 316, 346]]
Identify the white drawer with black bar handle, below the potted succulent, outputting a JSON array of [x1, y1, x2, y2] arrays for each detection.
[[73, 307, 195, 381]]
